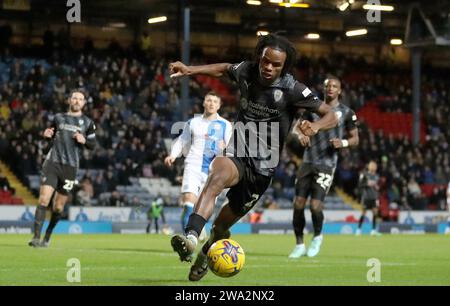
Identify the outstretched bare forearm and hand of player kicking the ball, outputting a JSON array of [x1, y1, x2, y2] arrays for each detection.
[[169, 62, 231, 78]]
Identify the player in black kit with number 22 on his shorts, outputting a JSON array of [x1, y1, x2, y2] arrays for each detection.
[[289, 76, 359, 258]]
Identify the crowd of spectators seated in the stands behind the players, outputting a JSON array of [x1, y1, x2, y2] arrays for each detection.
[[0, 41, 450, 209]]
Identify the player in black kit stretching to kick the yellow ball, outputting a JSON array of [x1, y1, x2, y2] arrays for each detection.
[[169, 34, 337, 281]]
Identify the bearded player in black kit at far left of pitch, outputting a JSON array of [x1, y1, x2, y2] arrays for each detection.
[[29, 89, 95, 247]]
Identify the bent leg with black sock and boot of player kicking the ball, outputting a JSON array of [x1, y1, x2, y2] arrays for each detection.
[[171, 157, 239, 261]]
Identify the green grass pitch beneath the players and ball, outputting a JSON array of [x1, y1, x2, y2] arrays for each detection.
[[0, 234, 450, 286]]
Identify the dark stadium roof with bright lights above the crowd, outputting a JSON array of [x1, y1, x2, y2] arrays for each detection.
[[0, 0, 450, 43]]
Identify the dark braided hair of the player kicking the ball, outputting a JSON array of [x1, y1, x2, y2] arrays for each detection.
[[254, 34, 297, 76]]
